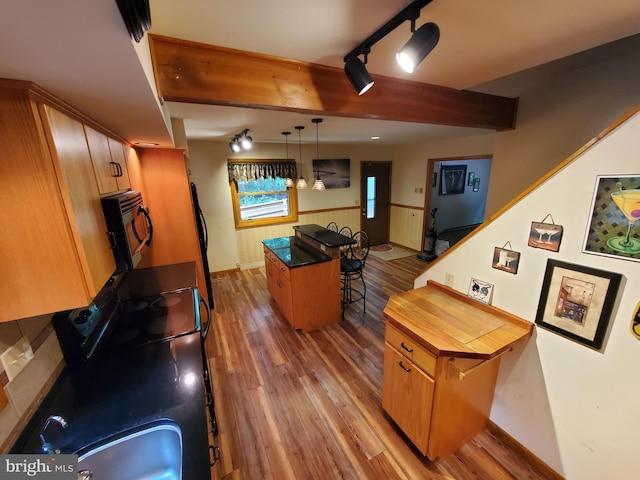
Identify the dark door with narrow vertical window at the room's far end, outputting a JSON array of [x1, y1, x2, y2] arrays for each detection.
[[360, 162, 391, 245]]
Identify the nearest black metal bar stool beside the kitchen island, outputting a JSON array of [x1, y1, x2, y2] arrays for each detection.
[[340, 231, 369, 320]]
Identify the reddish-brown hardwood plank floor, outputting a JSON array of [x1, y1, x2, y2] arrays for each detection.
[[207, 255, 543, 480]]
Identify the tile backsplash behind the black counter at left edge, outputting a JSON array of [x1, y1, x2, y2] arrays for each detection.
[[0, 315, 64, 453]]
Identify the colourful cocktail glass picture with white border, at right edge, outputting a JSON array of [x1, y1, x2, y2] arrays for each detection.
[[582, 174, 640, 262]]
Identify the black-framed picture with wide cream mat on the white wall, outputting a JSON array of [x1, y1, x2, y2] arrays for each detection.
[[536, 260, 622, 350]]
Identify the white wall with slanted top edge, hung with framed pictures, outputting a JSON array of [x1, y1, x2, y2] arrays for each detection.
[[416, 109, 640, 480]]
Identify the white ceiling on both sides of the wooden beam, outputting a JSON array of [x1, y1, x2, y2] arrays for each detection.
[[0, 0, 640, 146]]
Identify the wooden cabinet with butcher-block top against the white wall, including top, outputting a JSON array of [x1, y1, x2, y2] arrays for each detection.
[[382, 280, 533, 460]]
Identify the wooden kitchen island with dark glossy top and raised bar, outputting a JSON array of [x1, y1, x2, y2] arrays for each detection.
[[262, 225, 354, 332]]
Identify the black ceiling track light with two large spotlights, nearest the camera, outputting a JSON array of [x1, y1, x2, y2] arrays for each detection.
[[344, 0, 440, 95]]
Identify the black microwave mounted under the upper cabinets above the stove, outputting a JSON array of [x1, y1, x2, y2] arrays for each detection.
[[100, 190, 153, 273]]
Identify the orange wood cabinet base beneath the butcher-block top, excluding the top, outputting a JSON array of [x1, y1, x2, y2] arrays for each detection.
[[382, 325, 500, 460]]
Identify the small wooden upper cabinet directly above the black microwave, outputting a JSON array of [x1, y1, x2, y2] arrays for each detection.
[[84, 125, 131, 195]]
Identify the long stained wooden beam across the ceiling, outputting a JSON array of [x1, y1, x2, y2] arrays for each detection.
[[149, 35, 518, 130]]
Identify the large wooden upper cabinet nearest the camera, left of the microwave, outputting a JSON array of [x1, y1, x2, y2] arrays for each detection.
[[0, 80, 115, 321]]
